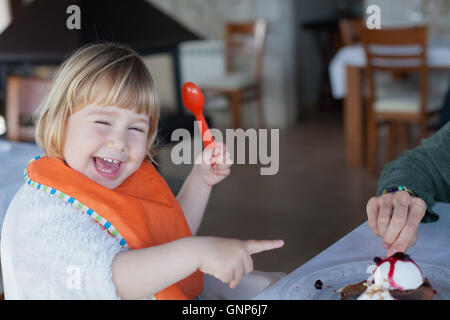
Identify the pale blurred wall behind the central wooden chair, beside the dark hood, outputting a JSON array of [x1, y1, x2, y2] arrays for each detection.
[[147, 0, 298, 128]]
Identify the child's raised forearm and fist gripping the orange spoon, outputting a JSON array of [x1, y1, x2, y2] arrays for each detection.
[[177, 143, 231, 235]]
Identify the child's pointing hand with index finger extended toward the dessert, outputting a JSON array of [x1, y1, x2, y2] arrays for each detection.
[[199, 237, 284, 288]]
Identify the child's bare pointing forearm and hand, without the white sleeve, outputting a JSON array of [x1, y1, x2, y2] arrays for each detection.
[[112, 237, 284, 299]]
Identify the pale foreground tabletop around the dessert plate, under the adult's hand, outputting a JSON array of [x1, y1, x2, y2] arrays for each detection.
[[254, 202, 450, 300]]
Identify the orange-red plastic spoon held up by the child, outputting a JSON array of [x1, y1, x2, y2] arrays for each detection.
[[181, 82, 214, 149]]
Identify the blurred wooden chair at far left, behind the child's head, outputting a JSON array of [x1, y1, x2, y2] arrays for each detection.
[[6, 76, 51, 142]]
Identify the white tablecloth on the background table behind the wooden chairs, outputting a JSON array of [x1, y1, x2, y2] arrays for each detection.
[[329, 45, 450, 99]]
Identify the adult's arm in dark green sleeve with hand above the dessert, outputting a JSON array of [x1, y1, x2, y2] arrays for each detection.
[[366, 125, 450, 255]]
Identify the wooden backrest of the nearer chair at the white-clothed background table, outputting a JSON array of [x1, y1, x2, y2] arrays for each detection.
[[360, 26, 428, 113]]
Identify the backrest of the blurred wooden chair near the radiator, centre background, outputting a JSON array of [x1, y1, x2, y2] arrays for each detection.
[[225, 19, 267, 79]]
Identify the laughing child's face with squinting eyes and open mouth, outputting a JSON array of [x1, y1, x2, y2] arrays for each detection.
[[63, 104, 149, 189]]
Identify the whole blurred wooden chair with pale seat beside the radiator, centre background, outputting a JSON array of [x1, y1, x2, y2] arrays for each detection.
[[199, 19, 267, 128]]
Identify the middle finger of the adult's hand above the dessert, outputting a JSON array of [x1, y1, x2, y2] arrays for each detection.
[[383, 191, 410, 244]]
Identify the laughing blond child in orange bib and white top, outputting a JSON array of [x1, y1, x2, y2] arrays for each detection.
[[1, 43, 283, 299]]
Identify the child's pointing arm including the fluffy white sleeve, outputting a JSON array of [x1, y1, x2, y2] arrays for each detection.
[[6, 184, 283, 300]]
